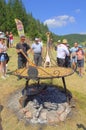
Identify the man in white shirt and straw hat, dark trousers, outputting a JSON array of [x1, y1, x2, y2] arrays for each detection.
[[57, 39, 69, 67]]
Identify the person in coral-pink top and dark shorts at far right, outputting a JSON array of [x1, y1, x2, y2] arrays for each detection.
[[76, 45, 85, 77]]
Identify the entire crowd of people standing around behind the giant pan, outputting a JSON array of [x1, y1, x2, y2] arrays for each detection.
[[0, 32, 85, 79]]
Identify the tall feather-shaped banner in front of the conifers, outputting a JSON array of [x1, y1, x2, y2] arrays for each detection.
[[15, 19, 25, 36]]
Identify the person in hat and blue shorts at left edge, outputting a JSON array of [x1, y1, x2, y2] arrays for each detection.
[[0, 34, 7, 79]]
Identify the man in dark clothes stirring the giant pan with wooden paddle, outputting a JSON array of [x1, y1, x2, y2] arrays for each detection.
[[16, 36, 30, 69]]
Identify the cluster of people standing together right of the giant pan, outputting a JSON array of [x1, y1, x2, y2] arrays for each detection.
[[57, 39, 85, 77]]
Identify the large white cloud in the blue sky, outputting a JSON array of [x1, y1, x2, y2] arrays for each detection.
[[44, 15, 75, 28]]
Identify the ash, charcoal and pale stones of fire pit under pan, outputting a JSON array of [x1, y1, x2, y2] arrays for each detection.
[[8, 85, 72, 124]]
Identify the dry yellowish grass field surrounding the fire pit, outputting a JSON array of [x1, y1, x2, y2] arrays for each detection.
[[0, 39, 86, 130]]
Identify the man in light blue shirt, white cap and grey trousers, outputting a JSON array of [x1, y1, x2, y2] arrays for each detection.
[[31, 38, 43, 66]]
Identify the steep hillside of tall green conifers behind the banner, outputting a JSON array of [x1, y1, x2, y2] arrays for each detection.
[[0, 0, 49, 40]]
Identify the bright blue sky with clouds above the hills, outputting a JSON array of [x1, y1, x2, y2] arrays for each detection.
[[22, 0, 86, 35]]
